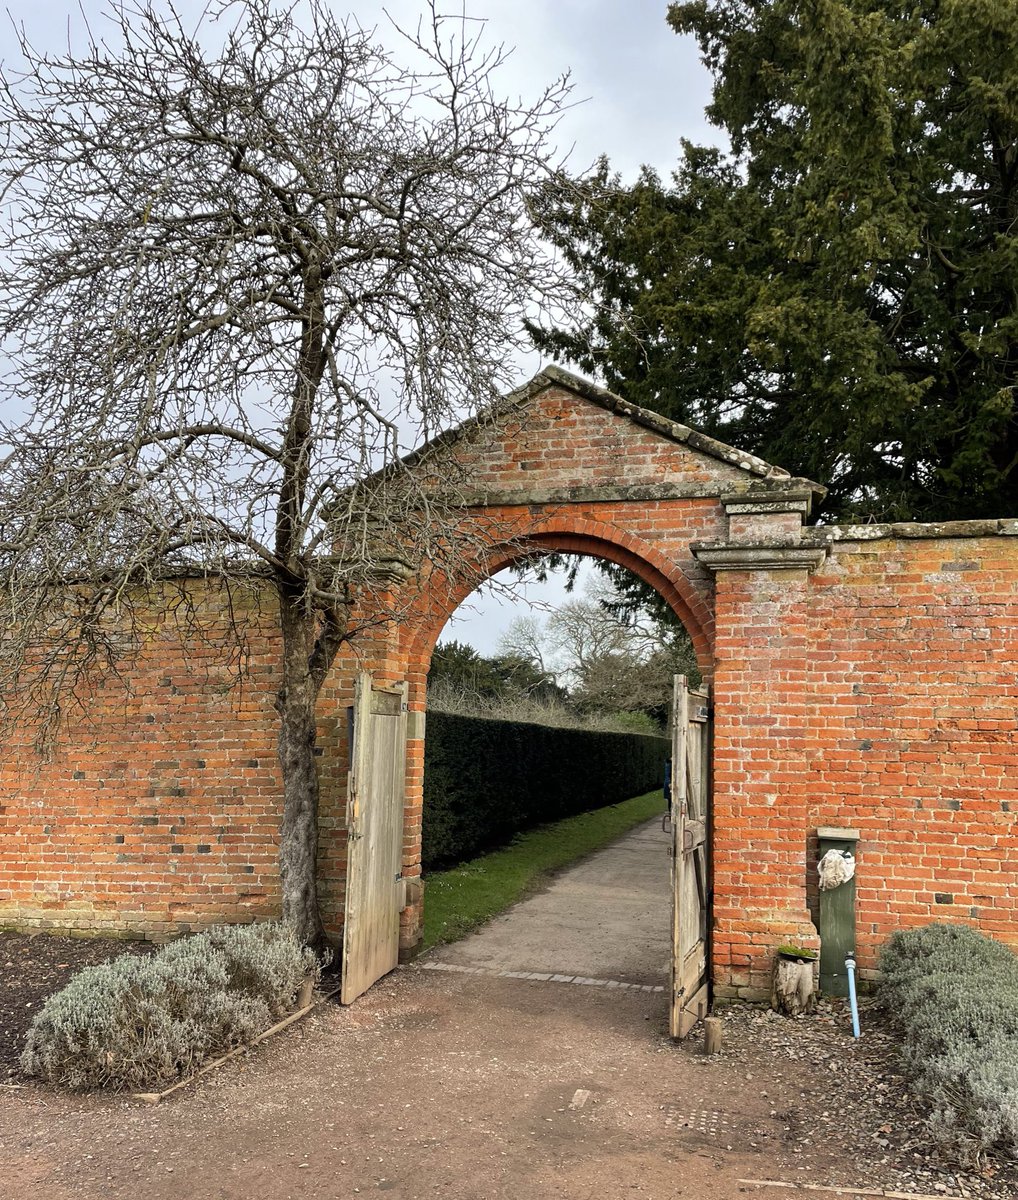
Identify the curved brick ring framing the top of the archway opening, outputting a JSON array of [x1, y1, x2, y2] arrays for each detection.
[[407, 517, 714, 679]]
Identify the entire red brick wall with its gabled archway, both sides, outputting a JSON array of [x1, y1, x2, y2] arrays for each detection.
[[0, 367, 1018, 1022]]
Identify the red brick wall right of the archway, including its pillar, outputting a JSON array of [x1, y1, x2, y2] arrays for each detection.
[[714, 530, 1018, 995]]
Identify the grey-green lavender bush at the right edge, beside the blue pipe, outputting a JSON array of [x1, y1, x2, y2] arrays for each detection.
[[880, 924, 1018, 1158]]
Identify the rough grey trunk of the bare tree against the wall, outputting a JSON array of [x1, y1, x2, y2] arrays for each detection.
[[276, 587, 325, 949]]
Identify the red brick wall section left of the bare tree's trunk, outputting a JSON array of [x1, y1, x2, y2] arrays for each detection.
[[0, 584, 280, 936]]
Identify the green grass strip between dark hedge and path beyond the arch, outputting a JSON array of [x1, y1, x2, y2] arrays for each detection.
[[423, 791, 665, 950]]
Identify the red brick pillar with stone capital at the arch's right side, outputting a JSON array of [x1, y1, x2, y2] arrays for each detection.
[[693, 496, 826, 1000]]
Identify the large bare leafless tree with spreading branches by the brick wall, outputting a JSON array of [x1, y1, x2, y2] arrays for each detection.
[[0, 0, 568, 942]]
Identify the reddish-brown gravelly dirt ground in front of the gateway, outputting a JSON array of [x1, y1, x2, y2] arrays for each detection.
[[0, 965, 1018, 1200]]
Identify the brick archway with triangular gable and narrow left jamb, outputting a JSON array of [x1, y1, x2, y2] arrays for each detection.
[[340, 368, 819, 969]]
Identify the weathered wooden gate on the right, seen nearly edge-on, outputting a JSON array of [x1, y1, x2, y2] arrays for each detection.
[[670, 676, 711, 1038]]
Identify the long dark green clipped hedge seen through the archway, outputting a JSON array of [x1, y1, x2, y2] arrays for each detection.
[[424, 712, 670, 871]]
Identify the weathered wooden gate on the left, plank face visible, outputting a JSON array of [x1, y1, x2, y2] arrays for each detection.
[[340, 672, 407, 1004]]
